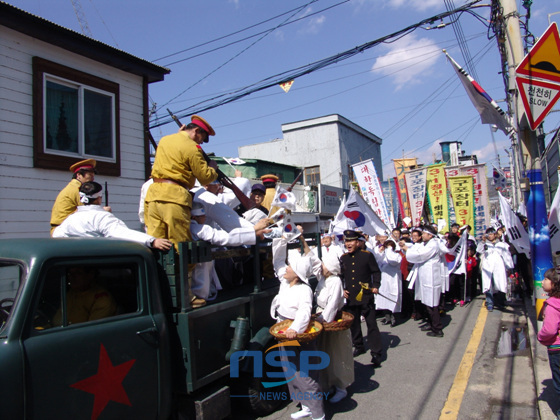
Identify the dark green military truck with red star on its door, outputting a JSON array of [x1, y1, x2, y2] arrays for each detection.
[[0, 238, 316, 419]]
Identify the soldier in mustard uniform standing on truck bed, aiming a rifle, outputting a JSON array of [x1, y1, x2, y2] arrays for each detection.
[[145, 115, 218, 248]]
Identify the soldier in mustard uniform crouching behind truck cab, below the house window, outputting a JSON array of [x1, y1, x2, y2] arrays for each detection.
[[51, 159, 99, 236]]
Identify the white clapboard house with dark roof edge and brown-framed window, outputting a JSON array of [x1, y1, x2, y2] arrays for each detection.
[[0, 2, 169, 238]]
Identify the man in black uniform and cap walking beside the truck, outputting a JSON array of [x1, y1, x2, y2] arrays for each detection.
[[340, 230, 383, 367]]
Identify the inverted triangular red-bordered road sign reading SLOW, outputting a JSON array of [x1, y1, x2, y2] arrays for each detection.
[[515, 76, 560, 130]]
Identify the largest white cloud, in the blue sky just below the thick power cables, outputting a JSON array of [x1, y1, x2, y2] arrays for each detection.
[[372, 34, 442, 89]]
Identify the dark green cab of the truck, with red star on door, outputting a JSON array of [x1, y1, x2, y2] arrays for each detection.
[[0, 239, 171, 418]]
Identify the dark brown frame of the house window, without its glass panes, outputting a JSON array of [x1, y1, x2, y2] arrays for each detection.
[[33, 57, 121, 176]]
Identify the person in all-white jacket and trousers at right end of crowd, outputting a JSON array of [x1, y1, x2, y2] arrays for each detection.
[[476, 228, 513, 312]]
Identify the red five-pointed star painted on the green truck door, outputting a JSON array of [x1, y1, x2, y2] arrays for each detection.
[[70, 344, 136, 420]]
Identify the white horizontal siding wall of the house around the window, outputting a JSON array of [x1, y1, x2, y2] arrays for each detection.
[[0, 26, 148, 238]]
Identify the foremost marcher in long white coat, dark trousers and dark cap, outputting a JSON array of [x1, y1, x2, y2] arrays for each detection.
[[402, 226, 443, 337]]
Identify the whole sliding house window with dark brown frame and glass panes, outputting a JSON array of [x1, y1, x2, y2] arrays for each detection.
[[33, 57, 120, 176]]
